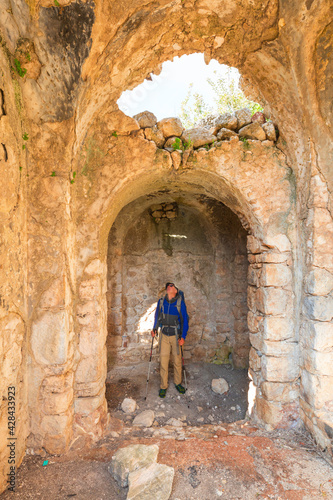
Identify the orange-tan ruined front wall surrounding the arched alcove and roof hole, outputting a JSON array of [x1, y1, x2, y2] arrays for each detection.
[[0, 0, 333, 489]]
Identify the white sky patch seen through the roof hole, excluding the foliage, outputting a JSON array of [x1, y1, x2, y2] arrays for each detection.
[[118, 54, 239, 120]]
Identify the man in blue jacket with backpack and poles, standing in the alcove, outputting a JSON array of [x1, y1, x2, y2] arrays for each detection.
[[151, 281, 188, 398]]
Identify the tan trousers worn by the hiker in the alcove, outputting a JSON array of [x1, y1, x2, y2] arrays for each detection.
[[160, 333, 182, 389]]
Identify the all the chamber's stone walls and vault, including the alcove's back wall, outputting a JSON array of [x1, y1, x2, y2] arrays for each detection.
[[0, 0, 333, 491]]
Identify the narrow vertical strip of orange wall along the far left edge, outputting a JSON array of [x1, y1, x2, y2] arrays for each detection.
[[0, 46, 29, 491]]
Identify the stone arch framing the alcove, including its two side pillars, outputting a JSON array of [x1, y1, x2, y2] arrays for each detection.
[[70, 135, 298, 442]]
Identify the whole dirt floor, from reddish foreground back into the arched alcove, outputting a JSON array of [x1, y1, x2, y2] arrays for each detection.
[[0, 364, 333, 500]]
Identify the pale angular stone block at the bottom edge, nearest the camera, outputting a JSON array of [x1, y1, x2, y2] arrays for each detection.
[[127, 464, 174, 500]]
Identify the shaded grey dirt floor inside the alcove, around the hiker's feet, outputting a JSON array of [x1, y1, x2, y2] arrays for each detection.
[[106, 363, 249, 425]]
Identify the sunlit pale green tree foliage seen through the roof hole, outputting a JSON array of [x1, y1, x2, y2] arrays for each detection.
[[179, 68, 262, 128]]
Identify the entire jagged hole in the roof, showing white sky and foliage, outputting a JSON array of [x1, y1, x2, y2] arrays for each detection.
[[117, 53, 262, 128]]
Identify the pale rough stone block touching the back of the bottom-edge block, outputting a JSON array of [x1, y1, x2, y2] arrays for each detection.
[[108, 444, 159, 488]]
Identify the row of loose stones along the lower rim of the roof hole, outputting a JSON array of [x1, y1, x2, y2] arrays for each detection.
[[133, 108, 277, 153]]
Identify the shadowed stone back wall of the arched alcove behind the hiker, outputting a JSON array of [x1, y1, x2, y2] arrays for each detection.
[[107, 197, 249, 369]]
